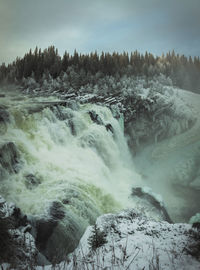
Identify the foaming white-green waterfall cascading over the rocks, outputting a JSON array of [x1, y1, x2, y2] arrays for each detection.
[[0, 90, 140, 259]]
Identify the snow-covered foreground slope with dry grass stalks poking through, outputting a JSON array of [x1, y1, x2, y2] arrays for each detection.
[[42, 210, 200, 270]]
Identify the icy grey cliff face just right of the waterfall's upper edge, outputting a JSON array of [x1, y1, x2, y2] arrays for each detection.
[[123, 87, 197, 149]]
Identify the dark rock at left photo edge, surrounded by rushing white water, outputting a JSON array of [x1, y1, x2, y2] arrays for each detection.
[[0, 142, 20, 173]]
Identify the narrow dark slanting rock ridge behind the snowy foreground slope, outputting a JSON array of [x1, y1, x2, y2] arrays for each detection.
[[131, 187, 173, 223]]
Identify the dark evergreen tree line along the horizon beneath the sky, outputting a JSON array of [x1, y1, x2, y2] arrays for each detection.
[[0, 46, 200, 92]]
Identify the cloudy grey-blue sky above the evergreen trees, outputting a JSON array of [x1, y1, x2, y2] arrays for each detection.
[[0, 0, 200, 63]]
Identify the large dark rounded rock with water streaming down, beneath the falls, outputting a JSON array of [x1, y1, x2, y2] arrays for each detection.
[[29, 201, 83, 264]]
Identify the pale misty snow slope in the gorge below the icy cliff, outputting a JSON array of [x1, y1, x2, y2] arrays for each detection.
[[134, 89, 200, 222]]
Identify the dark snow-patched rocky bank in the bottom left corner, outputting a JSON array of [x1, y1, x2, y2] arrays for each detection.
[[0, 196, 38, 270]]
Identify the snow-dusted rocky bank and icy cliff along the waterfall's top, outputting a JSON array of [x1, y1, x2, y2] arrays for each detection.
[[20, 74, 196, 153]]
